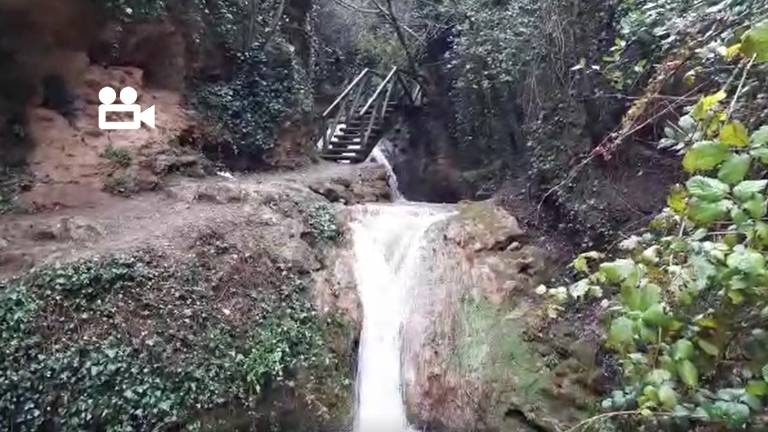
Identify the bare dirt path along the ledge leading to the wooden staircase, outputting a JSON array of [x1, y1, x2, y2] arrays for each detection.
[[0, 163, 389, 276]]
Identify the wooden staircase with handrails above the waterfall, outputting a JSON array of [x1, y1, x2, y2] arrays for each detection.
[[318, 68, 420, 163]]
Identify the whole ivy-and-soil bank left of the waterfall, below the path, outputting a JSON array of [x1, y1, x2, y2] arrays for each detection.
[[0, 173, 366, 432]]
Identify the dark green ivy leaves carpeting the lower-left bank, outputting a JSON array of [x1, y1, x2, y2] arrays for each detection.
[[0, 256, 349, 432]]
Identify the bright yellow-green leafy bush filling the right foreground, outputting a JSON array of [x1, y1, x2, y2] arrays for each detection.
[[540, 15, 768, 430]]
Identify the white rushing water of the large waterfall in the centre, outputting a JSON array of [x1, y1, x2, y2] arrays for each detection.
[[352, 201, 451, 432]]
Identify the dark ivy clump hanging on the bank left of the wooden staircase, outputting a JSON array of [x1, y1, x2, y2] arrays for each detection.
[[194, 45, 311, 159]]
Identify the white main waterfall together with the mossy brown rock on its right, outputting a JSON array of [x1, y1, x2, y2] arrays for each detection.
[[349, 187, 597, 432]]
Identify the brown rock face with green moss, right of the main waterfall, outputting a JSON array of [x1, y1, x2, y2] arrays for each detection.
[[405, 202, 596, 432]]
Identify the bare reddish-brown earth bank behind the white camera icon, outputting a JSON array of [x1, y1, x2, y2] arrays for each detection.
[[22, 63, 193, 210]]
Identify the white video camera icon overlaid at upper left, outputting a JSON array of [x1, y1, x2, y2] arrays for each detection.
[[99, 87, 155, 130]]
